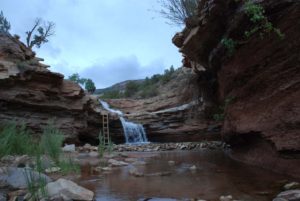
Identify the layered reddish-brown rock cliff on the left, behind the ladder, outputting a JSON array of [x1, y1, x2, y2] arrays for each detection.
[[0, 35, 123, 144]]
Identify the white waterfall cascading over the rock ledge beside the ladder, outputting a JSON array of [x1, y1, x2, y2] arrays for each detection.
[[100, 100, 148, 144]]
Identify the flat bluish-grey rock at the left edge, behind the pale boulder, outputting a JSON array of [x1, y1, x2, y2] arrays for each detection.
[[0, 167, 51, 189]]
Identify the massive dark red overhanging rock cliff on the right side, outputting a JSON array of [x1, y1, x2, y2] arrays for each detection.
[[173, 0, 300, 176]]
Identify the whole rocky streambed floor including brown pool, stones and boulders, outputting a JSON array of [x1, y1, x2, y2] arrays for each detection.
[[0, 141, 300, 201]]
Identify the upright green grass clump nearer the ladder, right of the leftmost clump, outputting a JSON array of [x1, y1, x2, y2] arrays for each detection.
[[40, 123, 64, 164]]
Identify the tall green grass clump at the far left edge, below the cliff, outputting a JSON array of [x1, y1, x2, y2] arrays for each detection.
[[0, 122, 37, 157]]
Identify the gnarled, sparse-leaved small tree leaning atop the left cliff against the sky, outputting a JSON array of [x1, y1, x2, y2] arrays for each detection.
[[26, 18, 55, 49]]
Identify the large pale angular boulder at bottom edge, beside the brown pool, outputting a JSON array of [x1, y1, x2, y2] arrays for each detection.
[[46, 179, 94, 200]]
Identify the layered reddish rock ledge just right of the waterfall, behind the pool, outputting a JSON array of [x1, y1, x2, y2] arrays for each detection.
[[107, 76, 220, 142]]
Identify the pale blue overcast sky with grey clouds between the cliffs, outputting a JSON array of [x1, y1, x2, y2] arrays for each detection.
[[0, 0, 181, 88]]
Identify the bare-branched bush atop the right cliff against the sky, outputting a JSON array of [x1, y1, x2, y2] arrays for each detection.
[[159, 0, 198, 26]]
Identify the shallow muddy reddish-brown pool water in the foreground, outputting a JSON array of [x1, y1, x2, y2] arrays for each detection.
[[79, 150, 295, 201]]
